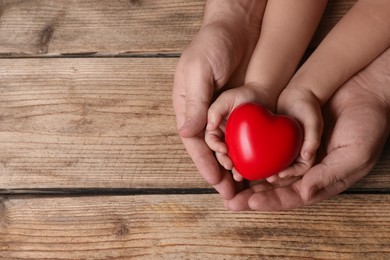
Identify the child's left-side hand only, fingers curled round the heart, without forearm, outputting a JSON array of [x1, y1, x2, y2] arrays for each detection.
[[205, 83, 276, 181]]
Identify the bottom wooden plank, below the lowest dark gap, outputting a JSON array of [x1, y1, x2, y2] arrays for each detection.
[[0, 195, 390, 260]]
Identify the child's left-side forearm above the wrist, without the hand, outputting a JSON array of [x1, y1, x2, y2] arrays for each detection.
[[245, 0, 327, 94]]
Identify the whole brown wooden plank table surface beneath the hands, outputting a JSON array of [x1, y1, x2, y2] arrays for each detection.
[[0, 0, 390, 259]]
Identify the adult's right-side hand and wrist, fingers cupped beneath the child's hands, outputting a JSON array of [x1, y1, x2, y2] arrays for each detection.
[[224, 47, 390, 210]]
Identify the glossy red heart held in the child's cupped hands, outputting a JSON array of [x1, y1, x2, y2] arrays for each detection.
[[225, 103, 303, 180]]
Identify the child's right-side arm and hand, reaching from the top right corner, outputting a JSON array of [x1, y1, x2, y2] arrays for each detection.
[[278, 0, 390, 178]]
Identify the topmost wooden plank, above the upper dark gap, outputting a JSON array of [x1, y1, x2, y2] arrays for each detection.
[[0, 0, 356, 56]]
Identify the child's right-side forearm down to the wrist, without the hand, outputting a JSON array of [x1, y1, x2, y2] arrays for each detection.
[[290, 0, 390, 103]]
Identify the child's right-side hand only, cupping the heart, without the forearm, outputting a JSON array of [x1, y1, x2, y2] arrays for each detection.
[[267, 86, 323, 182]]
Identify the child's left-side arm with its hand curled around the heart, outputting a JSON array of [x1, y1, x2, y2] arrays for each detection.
[[205, 0, 326, 181]]
